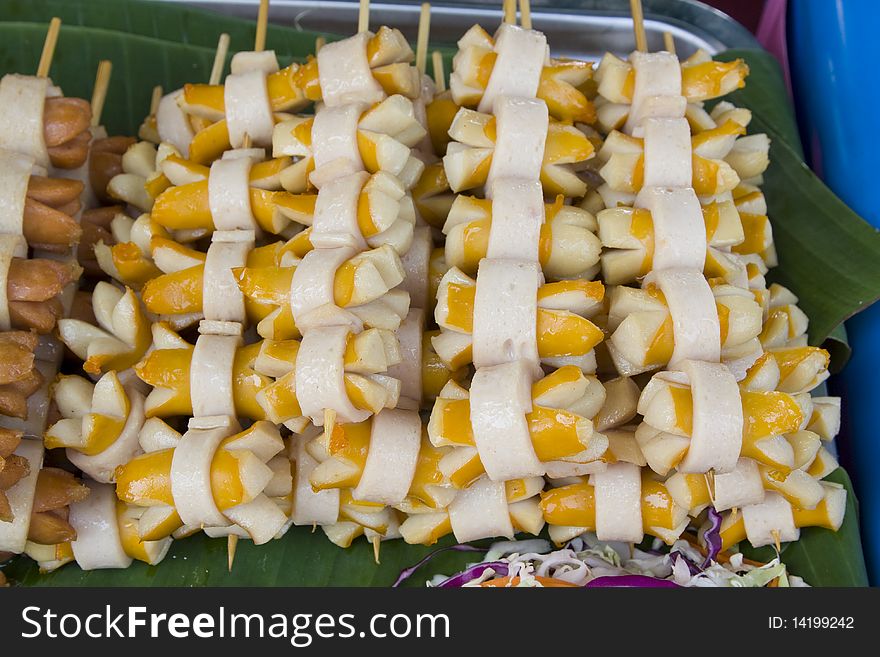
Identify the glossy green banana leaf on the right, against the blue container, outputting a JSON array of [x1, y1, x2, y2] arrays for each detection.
[[718, 50, 880, 371]]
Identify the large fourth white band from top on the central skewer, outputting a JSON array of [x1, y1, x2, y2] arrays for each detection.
[[473, 258, 541, 371]]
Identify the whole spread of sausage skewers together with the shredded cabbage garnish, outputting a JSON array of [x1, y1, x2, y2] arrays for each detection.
[[0, 0, 868, 587]]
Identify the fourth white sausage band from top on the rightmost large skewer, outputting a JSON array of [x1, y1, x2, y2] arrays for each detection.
[[643, 269, 721, 369]]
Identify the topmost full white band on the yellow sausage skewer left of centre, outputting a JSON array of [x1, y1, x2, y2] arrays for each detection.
[[223, 71, 275, 148]]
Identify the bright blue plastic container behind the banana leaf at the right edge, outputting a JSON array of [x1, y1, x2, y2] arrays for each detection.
[[788, 0, 880, 586]]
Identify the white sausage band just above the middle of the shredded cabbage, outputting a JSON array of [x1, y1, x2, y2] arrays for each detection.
[[591, 462, 644, 543]]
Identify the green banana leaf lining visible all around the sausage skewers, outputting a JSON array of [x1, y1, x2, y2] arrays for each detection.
[[0, 11, 868, 586]]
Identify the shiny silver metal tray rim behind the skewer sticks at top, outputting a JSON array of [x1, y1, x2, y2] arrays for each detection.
[[164, 0, 760, 60]]
